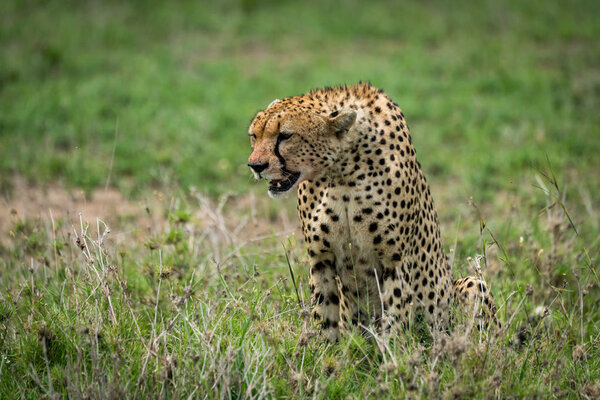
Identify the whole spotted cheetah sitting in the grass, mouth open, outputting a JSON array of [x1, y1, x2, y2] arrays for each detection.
[[248, 83, 489, 341]]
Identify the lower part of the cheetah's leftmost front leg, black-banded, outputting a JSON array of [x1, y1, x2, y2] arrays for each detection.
[[309, 255, 340, 341]]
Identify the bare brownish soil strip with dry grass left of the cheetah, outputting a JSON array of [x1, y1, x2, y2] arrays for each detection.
[[0, 179, 301, 247]]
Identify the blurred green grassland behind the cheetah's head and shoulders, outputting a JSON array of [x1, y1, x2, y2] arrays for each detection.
[[0, 0, 600, 199]]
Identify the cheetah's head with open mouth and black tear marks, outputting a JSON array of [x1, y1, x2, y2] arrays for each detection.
[[248, 98, 356, 198]]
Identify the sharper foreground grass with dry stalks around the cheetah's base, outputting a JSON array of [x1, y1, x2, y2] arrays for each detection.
[[0, 168, 600, 398]]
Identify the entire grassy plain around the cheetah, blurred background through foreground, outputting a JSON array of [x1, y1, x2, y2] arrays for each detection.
[[0, 1, 600, 398]]
